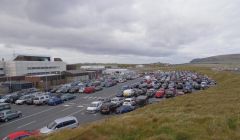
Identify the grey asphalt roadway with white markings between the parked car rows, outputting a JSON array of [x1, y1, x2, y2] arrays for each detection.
[[0, 79, 140, 138]]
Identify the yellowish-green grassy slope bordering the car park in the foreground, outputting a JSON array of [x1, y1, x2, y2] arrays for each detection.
[[30, 67, 240, 140]]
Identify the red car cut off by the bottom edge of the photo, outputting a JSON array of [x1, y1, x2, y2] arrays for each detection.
[[2, 131, 37, 140]]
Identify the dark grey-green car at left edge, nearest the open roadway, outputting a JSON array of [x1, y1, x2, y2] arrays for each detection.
[[0, 110, 22, 122]]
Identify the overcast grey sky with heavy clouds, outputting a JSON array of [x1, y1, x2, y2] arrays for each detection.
[[0, 0, 240, 63]]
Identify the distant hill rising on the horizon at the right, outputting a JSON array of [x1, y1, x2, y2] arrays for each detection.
[[190, 54, 240, 64]]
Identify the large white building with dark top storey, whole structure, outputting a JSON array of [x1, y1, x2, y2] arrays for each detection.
[[5, 55, 66, 76]]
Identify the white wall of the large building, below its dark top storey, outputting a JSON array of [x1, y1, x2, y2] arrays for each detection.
[[6, 61, 66, 76]]
